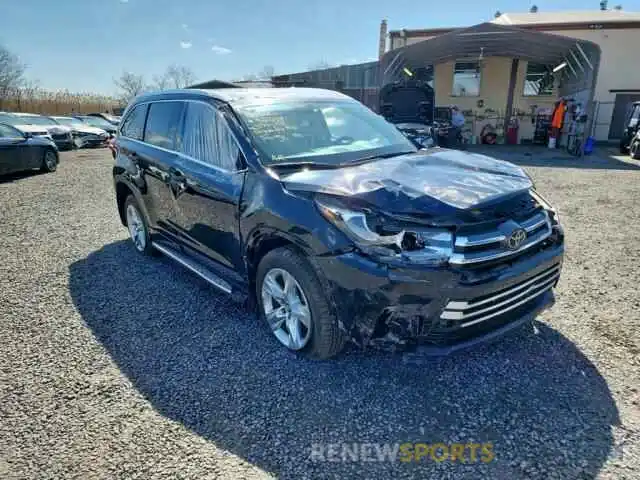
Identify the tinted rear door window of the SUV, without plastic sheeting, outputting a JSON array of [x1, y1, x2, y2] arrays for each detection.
[[144, 102, 184, 150]]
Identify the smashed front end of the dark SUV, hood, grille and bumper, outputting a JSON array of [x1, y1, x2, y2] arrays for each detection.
[[282, 149, 564, 354]]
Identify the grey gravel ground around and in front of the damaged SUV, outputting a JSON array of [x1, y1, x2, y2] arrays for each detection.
[[0, 150, 640, 479]]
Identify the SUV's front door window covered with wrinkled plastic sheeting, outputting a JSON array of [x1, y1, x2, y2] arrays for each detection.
[[181, 102, 240, 171]]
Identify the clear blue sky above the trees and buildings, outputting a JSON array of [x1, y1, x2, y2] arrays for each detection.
[[0, 0, 640, 94]]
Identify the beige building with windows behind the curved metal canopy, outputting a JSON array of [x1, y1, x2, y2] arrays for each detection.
[[380, 10, 640, 140]]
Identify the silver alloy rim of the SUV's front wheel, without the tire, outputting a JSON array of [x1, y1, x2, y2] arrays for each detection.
[[261, 268, 312, 350]]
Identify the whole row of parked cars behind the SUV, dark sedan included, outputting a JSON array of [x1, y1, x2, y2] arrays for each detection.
[[0, 112, 120, 175]]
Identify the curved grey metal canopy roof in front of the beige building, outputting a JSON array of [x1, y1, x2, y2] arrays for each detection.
[[381, 22, 600, 83]]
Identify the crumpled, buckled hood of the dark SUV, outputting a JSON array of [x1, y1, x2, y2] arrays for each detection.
[[281, 148, 532, 213]]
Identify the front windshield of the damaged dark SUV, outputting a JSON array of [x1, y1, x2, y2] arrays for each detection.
[[236, 100, 416, 165]]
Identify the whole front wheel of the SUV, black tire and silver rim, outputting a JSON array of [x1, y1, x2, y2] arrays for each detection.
[[256, 247, 346, 359]]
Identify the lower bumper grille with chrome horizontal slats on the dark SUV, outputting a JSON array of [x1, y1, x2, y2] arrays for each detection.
[[440, 265, 560, 328]]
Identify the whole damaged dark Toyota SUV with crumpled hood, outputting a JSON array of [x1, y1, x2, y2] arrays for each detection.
[[113, 88, 564, 358]]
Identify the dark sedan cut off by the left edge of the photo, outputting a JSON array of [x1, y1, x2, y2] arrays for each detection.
[[0, 123, 59, 175]]
